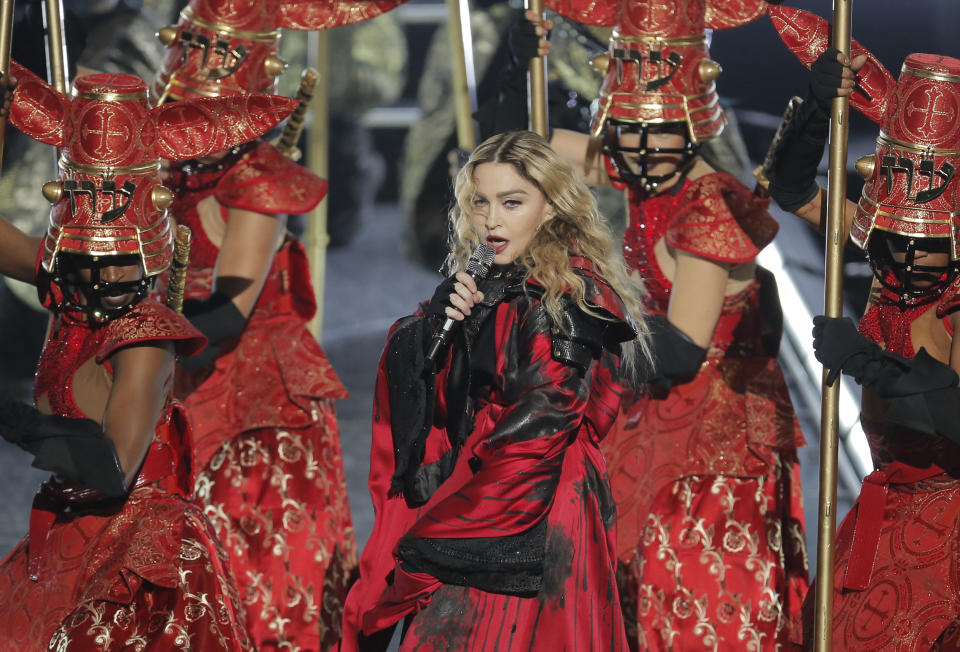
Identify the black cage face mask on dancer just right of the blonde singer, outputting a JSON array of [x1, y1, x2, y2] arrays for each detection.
[[603, 120, 698, 194]]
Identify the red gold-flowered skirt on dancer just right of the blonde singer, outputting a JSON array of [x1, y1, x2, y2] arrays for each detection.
[[618, 463, 807, 651]]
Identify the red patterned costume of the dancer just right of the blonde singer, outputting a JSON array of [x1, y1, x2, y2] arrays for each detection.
[[601, 173, 808, 650]]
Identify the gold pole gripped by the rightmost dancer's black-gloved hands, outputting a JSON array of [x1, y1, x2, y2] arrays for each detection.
[[814, 0, 852, 652]]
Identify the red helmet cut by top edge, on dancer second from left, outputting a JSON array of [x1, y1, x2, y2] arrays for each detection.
[[154, 0, 406, 103]]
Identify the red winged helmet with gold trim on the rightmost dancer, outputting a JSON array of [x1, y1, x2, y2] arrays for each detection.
[[770, 7, 960, 300]]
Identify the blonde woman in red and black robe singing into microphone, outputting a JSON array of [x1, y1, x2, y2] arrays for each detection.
[[341, 132, 640, 651]]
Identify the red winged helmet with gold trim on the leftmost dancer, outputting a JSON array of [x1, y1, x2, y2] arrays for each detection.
[[10, 62, 296, 320]]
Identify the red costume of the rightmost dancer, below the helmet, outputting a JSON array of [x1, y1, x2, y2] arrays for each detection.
[[804, 290, 960, 652]]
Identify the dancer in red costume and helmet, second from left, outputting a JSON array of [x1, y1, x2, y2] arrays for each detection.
[[154, 0, 404, 650]]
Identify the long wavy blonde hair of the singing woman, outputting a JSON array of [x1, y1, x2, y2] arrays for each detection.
[[444, 131, 649, 374]]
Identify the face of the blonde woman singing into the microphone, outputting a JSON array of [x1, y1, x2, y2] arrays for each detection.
[[470, 163, 554, 265]]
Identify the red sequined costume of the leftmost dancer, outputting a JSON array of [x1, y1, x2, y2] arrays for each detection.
[[0, 299, 249, 651]]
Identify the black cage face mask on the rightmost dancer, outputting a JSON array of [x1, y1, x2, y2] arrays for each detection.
[[867, 231, 960, 306]]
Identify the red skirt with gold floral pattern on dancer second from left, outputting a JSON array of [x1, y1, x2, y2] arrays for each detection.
[[196, 399, 356, 651]]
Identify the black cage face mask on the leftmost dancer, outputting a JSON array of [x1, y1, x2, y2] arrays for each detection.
[[51, 254, 156, 324]]
